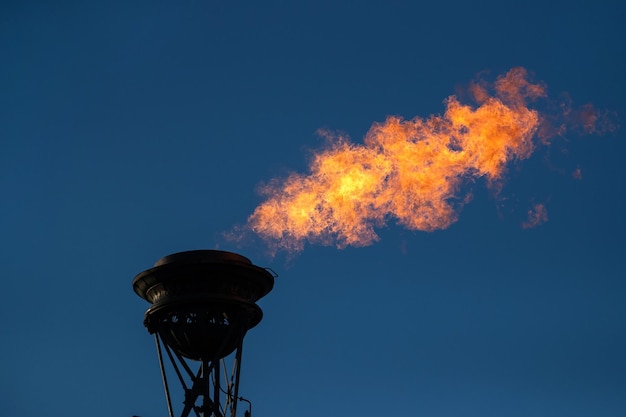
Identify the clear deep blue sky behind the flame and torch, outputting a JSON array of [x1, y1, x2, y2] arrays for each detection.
[[0, 0, 626, 417]]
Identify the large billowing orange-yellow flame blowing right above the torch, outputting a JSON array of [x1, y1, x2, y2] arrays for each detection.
[[248, 68, 545, 251]]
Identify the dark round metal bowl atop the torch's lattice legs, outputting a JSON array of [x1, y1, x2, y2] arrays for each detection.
[[133, 250, 274, 361]]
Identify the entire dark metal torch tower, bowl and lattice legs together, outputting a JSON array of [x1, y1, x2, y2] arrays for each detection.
[[133, 250, 275, 417]]
